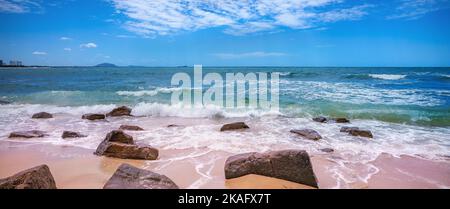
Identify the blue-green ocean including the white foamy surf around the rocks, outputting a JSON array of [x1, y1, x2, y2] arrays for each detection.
[[0, 67, 450, 187]]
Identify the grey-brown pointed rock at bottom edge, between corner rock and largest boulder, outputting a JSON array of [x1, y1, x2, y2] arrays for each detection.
[[103, 164, 178, 189]]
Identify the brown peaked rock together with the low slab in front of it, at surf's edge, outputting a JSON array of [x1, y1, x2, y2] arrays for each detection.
[[94, 130, 159, 160]]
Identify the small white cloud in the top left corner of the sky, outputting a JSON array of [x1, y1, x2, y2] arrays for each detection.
[[0, 0, 42, 13]]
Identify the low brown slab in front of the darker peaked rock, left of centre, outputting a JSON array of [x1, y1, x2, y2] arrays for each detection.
[[94, 141, 159, 160]]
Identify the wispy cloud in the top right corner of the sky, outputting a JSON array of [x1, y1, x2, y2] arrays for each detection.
[[387, 0, 450, 20]]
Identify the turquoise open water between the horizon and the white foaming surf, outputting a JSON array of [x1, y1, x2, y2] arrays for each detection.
[[0, 67, 450, 127]]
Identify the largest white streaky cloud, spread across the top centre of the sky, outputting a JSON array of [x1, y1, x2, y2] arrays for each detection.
[[109, 0, 368, 37]]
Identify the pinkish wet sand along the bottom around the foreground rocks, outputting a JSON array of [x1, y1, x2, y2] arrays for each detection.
[[0, 141, 450, 189]]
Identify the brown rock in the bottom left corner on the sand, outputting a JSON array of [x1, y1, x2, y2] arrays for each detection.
[[0, 165, 56, 189]]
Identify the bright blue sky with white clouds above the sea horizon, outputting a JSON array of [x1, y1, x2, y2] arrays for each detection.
[[0, 0, 450, 67]]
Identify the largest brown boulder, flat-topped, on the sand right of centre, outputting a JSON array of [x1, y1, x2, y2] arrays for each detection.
[[225, 150, 318, 188]]
